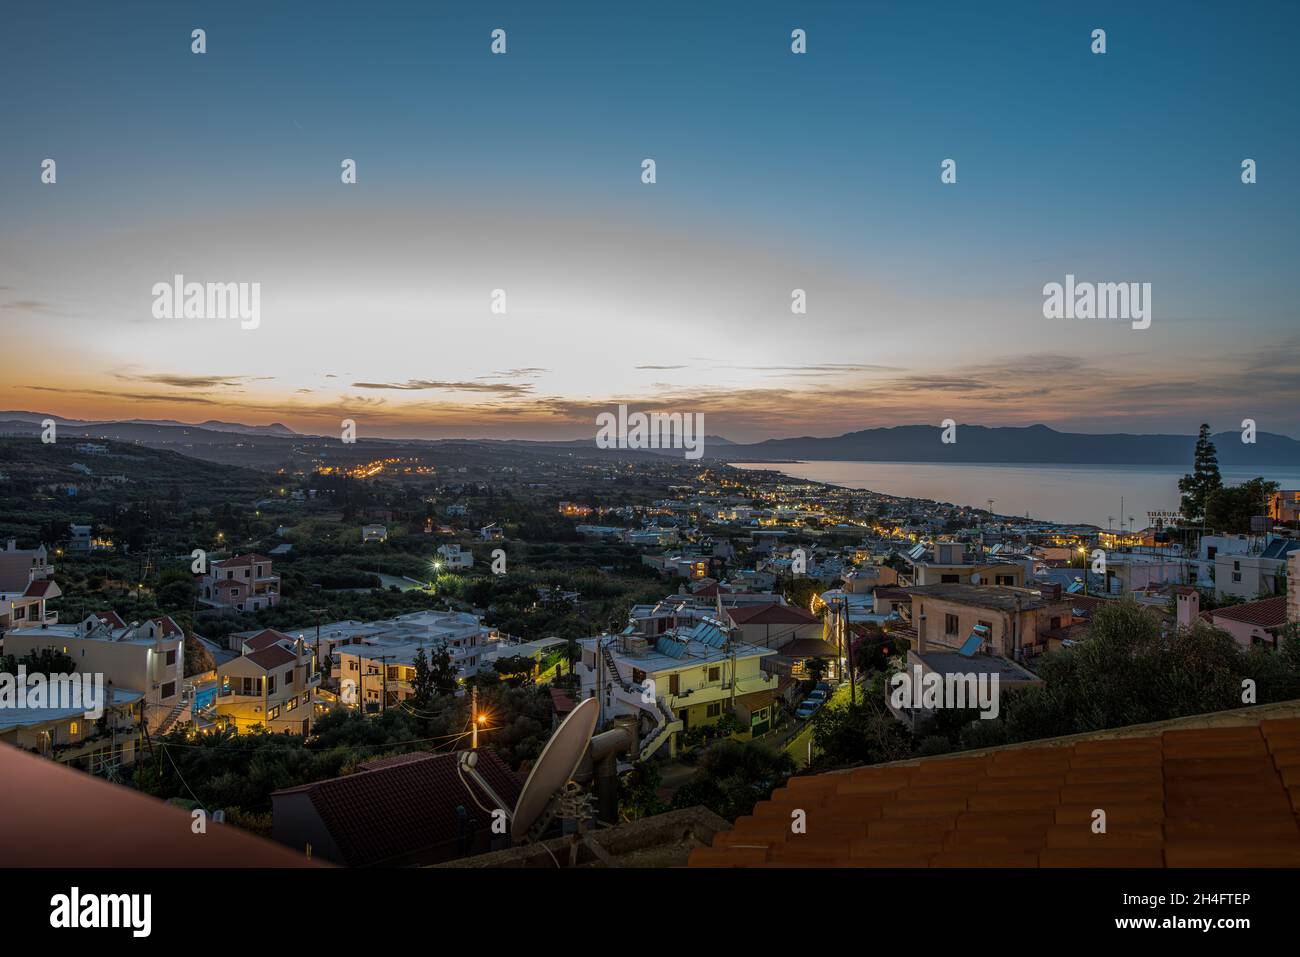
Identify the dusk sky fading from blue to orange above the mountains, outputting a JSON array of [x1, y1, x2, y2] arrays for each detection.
[[0, 0, 1300, 441]]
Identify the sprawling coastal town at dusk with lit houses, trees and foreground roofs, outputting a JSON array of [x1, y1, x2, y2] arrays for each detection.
[[0, 430, 1300, 867]]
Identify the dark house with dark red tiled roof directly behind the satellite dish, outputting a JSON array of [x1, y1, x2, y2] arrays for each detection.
[[270, 748, 523, 867]]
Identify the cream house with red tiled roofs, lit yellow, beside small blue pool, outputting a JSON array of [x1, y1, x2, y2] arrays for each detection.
[[216, 629, 321, 735]]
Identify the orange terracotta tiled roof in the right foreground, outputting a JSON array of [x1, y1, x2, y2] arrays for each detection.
[[689, 719, 1300, 867]]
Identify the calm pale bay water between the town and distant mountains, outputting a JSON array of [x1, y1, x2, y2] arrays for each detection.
[[733, 462, 1300, 528]]
